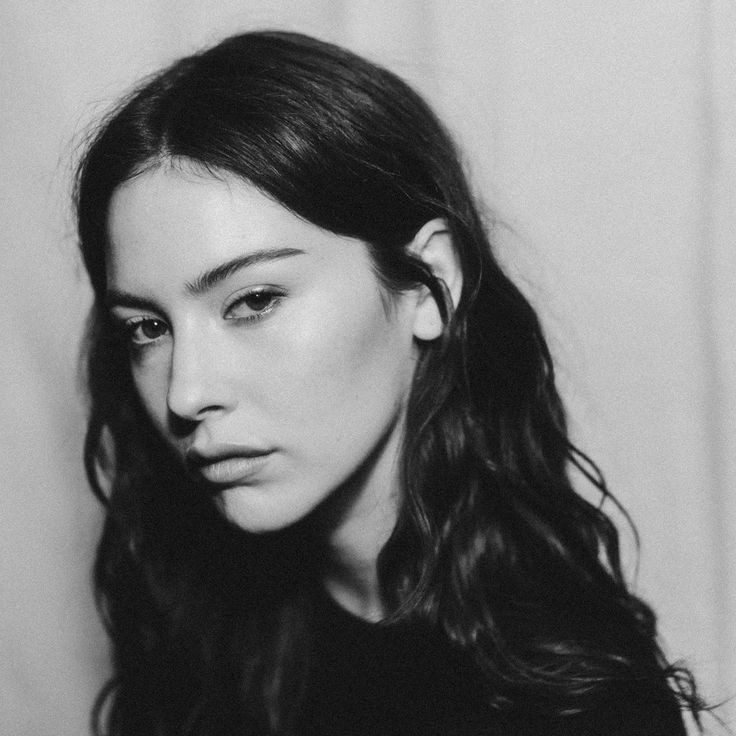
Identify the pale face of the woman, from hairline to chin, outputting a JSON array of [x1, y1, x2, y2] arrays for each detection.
[[107, 165, 418, 532]]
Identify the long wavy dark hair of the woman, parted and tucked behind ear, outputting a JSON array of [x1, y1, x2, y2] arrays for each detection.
[[76, 32, 699, 736]]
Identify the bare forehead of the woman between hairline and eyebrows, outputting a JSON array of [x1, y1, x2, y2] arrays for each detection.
[[106, 166, 369, 289]]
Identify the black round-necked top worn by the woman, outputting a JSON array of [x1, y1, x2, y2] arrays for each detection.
[[297, 596, 685, 736]]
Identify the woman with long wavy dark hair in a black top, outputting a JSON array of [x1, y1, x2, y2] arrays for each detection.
[[76, 32, 701, 736]]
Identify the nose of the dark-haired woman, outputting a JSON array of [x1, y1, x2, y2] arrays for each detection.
[[166, 335, 231, 422]]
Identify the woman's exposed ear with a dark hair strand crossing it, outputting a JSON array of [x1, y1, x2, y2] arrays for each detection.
[[408, 218, 463, 340]]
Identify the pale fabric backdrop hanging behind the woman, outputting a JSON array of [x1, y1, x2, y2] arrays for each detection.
[[0, 0, 736, 736]]
